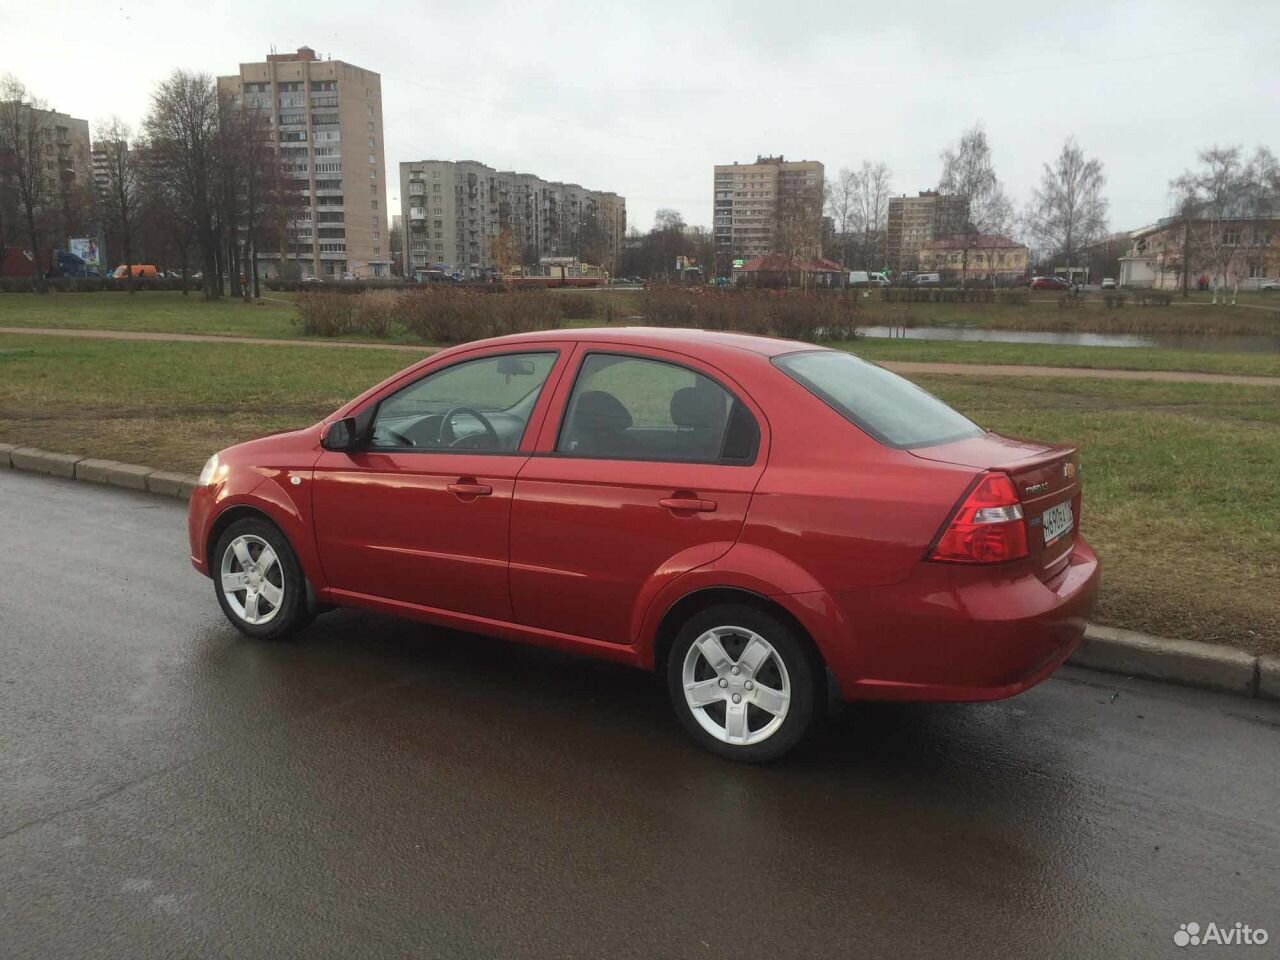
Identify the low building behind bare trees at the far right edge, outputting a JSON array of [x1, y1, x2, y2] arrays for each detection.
[[1119, 216, 1280, 289]]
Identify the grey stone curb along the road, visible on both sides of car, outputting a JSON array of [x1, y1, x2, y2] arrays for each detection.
[[0, 443, 1280, 700]]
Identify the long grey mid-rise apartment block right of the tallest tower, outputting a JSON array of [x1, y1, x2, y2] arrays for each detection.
[[399, 160, 627, 279]]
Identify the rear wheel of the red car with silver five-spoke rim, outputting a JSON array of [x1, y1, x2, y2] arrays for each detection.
[[667, 604, 824, 763]]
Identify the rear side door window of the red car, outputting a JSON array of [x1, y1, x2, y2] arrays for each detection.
[[556, 353, 760, 463]]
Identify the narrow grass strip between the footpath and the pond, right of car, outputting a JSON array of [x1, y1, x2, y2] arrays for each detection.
[[831, 337, 1280, 376]]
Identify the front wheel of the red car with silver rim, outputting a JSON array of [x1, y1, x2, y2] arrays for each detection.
[[210, 517, 314, 640]]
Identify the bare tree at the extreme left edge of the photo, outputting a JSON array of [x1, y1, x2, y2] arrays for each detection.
[[0, 74, 52, 288]]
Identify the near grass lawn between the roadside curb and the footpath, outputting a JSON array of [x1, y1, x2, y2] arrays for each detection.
[[0, 335, 1280, 653]]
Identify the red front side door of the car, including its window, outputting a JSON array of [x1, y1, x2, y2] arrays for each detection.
[[312, 348, 559, 621]]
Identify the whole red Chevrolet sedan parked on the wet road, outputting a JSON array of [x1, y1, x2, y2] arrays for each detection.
[[189, 329, 1098, 760]]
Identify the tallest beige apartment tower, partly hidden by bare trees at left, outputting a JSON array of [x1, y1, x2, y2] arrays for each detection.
[[218, 46, 392, 278]]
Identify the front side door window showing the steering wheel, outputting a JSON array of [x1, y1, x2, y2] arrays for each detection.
[[369, 351, 557, 452]]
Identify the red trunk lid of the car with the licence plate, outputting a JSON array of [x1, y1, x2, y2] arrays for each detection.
[[911, 433, 1082, 580]]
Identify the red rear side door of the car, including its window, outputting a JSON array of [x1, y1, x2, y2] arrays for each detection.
[[511, 344, 768, 644]]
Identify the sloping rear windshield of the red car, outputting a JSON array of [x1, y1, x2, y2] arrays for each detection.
[[773, 349, 983, 447]]
